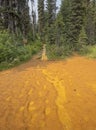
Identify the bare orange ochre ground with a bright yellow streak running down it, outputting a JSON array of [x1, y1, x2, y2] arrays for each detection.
[[0, 57, 96, 130]]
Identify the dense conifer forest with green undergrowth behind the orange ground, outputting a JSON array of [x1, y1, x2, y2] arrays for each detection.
[[0, 0, 96, 68]]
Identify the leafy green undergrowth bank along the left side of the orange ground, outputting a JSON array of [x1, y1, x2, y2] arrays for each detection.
[[0, 31, 41, 70]]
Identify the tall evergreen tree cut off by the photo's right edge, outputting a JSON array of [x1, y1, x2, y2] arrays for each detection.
[[86, 0, 96, 45]]
